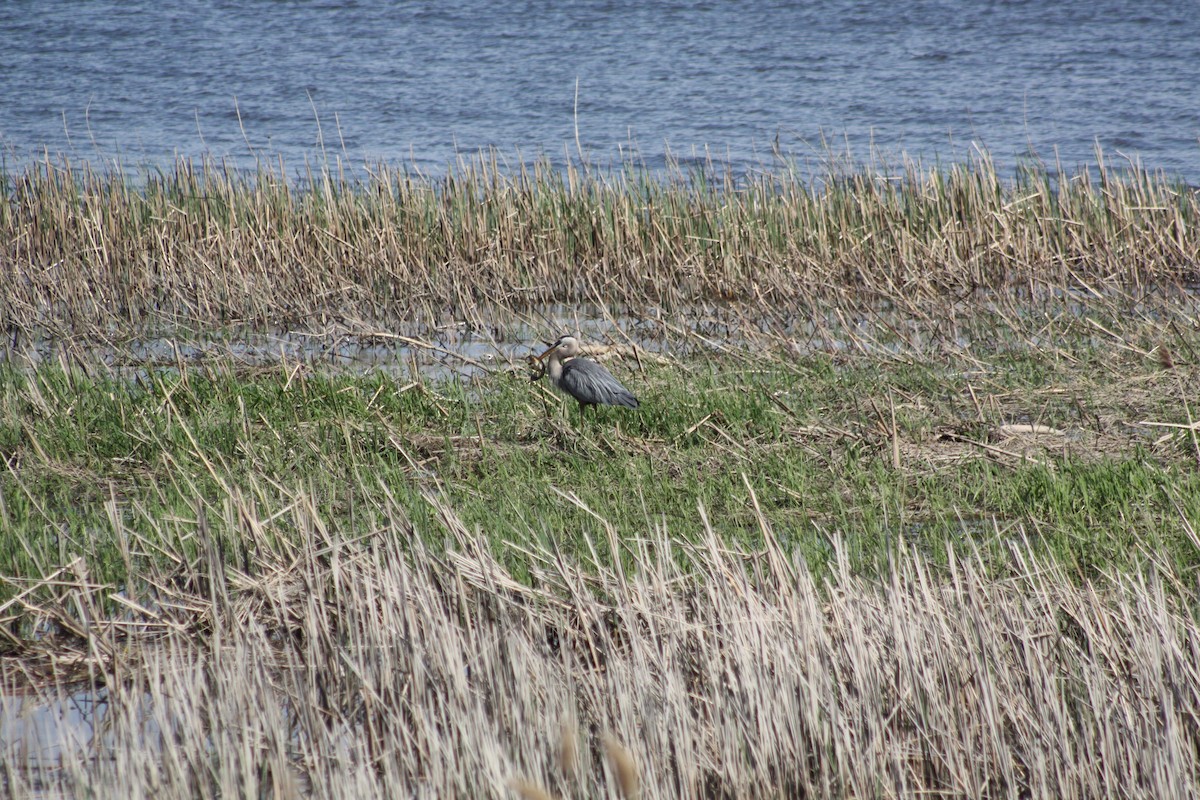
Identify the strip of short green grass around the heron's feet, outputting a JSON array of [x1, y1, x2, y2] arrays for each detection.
[[0, 333, 1200, 606]]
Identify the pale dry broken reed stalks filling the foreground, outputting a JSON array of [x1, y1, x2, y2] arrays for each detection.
[[0, 493, 1200, 799]]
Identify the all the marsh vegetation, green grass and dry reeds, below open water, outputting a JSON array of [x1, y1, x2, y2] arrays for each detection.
[[0, 153, 1200, 798]]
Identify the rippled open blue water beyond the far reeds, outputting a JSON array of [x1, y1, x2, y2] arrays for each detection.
[[0, 0, 1200, 184]]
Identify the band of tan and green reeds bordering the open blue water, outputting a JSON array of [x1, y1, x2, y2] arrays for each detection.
[[0, 154, 1200, 337]]
